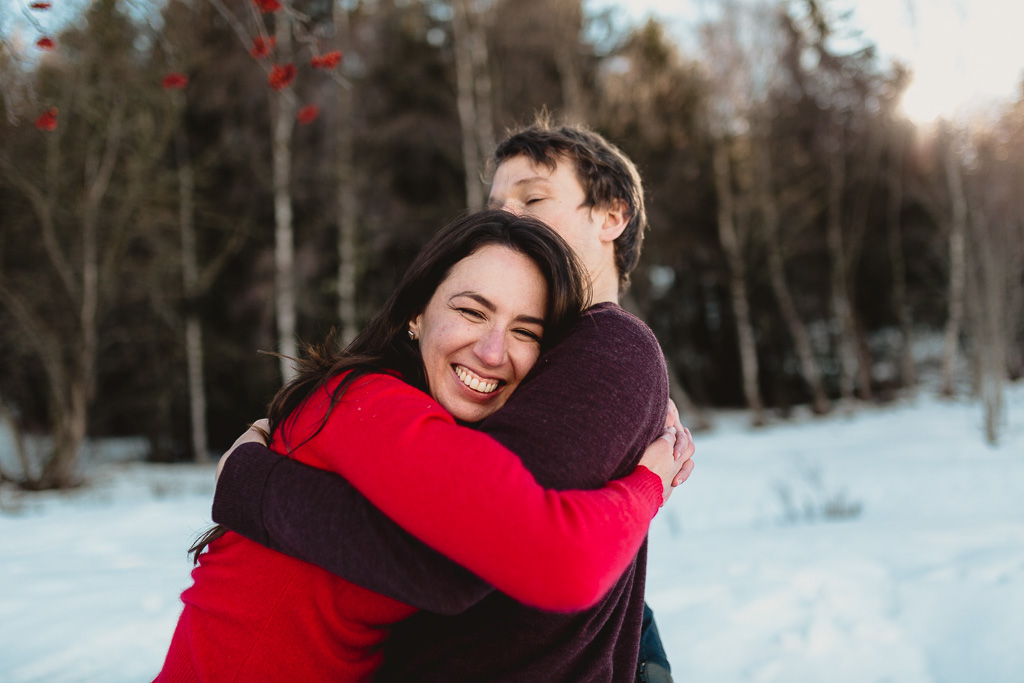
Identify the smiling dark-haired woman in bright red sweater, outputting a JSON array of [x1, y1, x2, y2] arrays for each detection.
[[157, 211, 678, 681]]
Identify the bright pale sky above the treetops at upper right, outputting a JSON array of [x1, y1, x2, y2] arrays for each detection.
[[588, 0, 1024, 123]]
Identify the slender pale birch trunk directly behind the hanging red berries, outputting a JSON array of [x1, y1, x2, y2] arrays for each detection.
[[270, 12, 298, 383]]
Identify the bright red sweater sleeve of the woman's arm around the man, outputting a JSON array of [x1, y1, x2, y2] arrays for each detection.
[[271, 375, 662, 610]]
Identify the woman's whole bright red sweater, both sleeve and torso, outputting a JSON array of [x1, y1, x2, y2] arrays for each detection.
[[157, 375, 662, 681]]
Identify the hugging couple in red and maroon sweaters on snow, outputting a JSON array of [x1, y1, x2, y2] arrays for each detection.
[[151, 120, 694, 682]]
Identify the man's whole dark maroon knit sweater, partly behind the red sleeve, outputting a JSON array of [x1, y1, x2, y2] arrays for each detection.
[[213, 304, 669, 682]]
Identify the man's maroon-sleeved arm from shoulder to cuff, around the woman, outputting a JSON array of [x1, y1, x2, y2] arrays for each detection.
[[214, 311, 668, 613]]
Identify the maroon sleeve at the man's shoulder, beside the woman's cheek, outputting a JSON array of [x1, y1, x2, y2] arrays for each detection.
[[480, 306, 669, 488]]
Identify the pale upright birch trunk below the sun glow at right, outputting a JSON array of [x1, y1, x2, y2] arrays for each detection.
[[940, 134, 967, 396]]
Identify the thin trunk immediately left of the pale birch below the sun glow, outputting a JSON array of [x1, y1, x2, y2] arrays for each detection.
[[887, 120, 918, 392]]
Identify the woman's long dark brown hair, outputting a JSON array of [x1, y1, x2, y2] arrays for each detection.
[[188, 210, 590, 562]]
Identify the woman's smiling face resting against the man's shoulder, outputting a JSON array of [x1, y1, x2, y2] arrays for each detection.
[[409, 245, 548, 422]]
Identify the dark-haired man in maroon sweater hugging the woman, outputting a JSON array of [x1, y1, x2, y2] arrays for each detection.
[[214, 122, 692, 682]]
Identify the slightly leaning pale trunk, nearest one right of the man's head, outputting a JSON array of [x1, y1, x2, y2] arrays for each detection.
[[713, 139, 764, 426]]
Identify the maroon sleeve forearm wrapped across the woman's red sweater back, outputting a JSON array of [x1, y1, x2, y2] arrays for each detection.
[[213, 443, 494, 614]]
